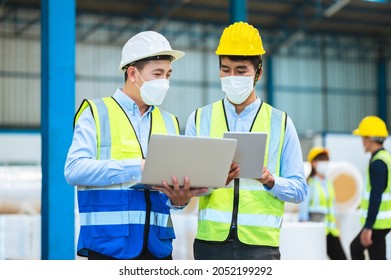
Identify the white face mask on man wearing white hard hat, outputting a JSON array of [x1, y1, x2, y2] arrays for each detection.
[[136, 71, 170, 105]]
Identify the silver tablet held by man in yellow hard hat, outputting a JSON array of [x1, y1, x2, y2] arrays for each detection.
[[224, 132, 267, 178]]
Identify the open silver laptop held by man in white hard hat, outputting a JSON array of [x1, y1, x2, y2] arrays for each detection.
[[141, 134, 237, 188]]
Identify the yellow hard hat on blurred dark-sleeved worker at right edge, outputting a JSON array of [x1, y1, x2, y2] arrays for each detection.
[[353, 116, 388, 138]]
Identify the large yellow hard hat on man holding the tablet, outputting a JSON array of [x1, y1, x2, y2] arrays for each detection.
[[216, 21, 265, 56]]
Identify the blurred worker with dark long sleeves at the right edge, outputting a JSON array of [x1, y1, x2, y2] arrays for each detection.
[[350, 116, 391, 260]]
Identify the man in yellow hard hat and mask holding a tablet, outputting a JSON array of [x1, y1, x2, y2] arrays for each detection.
[[186, 22, 307, 259]]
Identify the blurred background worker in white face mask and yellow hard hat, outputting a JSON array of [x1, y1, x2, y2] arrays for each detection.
[[299, 146, 347, 260]]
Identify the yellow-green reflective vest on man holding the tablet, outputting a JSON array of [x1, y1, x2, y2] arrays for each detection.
[[196, 100, 286, 246]]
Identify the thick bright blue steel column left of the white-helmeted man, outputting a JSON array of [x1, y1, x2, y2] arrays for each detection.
[[41, 0, 76, 260]]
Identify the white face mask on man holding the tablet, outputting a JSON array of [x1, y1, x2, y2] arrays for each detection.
[[220, 76, 254, 104]]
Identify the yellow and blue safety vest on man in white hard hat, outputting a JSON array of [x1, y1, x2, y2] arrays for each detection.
[[75, 97, 179, 258]]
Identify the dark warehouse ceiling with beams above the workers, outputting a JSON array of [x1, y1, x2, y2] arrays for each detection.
[[0, 0, 391, 52]]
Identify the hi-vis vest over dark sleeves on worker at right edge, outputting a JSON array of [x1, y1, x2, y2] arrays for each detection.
[[360, 150, 391, 229]]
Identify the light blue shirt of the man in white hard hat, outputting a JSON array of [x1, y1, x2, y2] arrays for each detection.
[[64, 89, 153, 186]]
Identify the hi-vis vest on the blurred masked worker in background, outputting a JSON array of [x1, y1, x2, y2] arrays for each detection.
[[308, 177, 340, 236]]
